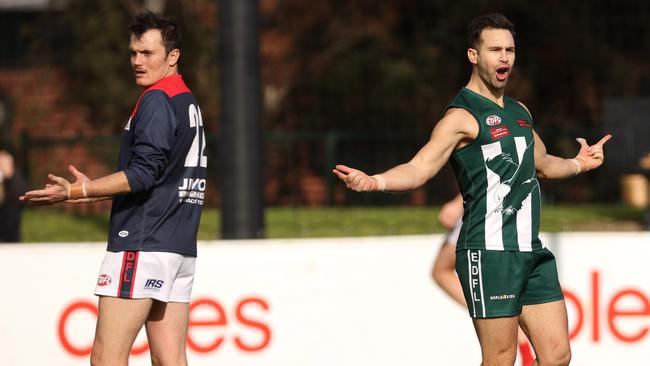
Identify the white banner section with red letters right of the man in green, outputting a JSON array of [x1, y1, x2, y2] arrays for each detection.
[[552, 233, 650, 366]]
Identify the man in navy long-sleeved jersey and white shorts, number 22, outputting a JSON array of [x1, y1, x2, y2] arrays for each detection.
[[21, 12, 207, 366]]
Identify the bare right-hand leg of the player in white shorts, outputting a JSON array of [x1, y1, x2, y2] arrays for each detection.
[[145, 301, 190, 366]]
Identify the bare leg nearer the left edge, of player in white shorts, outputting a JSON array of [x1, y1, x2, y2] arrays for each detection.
[[90, 296, 153, 366]]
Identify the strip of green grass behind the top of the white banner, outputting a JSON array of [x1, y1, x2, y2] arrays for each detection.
[[21, 205, 643, 242]]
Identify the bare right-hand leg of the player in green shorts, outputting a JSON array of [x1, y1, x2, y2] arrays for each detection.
[[519, 300, 571, 366]]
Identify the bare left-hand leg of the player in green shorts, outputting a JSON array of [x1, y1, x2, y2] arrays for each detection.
[[474, 316, 518, 366]]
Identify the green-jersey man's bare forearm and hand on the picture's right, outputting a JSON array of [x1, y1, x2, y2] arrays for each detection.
[[533, 131, 612, 179]]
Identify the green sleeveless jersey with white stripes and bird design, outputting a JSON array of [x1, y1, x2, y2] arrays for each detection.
[[447, 88, 542, 251]]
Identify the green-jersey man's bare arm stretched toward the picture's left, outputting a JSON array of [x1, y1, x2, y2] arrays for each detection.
[[332, 109, 478, 192]]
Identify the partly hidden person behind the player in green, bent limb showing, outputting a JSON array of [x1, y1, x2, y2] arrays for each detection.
[[431, 194, 535, 366]]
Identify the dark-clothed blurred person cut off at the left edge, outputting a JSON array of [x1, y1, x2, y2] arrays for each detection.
[[0, 150, 27, 243]]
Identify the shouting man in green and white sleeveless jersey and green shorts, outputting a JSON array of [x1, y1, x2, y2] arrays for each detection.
[[333, 14, 611, 366]]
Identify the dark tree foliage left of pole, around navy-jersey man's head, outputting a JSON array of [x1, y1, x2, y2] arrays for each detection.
[[39, 0, 217, 132]]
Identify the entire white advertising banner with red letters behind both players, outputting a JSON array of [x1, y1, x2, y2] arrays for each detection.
[[0, 233, 650, 366]]
